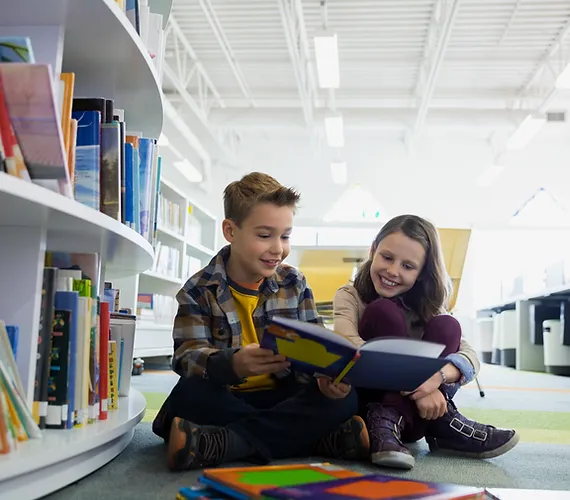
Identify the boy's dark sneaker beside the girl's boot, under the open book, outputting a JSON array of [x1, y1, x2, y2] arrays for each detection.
[[316, 415, 370, 460]]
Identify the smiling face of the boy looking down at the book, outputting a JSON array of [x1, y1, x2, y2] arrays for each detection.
[[222, 203, 294, 283]]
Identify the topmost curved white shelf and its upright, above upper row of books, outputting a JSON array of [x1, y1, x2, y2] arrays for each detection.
[[0, 0, 163, 138]]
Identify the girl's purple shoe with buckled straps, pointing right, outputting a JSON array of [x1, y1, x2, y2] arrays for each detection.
[[426, 400, 519, 458]]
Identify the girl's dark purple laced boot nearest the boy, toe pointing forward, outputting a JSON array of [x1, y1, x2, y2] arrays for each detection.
[[367, 403, 415, 469]]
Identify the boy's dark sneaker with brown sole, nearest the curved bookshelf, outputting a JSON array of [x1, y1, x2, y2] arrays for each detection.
[[168, 417, 229, 470]]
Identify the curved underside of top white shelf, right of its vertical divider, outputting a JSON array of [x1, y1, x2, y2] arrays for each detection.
[[62, 0, 164, 138]]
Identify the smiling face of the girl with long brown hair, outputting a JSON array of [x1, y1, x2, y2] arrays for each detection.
[[370, 231, 426, 298]]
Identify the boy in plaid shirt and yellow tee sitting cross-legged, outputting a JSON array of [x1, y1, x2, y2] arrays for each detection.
[[153, 173, 369, 470]]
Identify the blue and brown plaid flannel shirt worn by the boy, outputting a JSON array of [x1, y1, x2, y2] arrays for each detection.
[[172, 245, 322, 377]]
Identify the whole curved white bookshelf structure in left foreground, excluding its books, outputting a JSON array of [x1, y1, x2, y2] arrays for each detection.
[[0, 0, 166, 500]]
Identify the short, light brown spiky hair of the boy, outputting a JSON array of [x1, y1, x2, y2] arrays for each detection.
[[224, 172, 301, 225]]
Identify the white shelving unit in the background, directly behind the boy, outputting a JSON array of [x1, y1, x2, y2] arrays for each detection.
[[113, 179, 218, 358]]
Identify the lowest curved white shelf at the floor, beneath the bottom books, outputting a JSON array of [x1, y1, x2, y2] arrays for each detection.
[[0, 389, 146, 500]]
